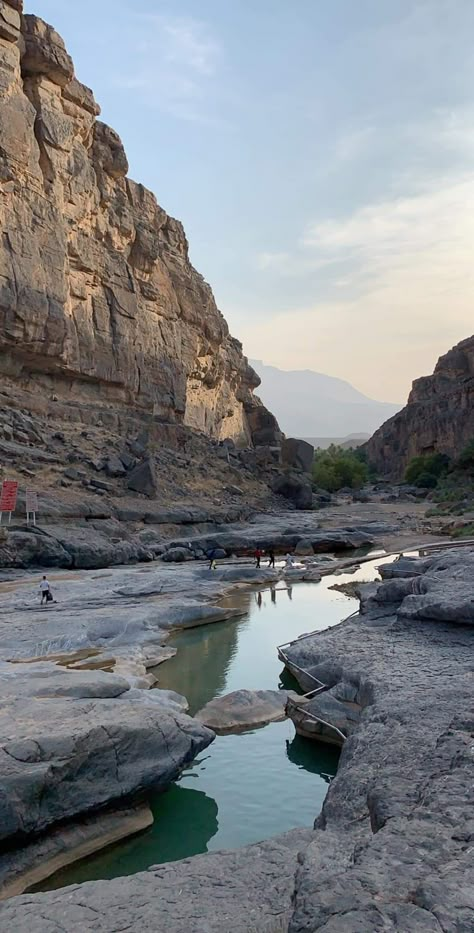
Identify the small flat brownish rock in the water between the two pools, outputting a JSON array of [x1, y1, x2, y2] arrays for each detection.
[[195, 690, 296, 735]]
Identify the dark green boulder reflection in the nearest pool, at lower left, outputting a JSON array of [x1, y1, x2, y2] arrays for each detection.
[[38, 784, 218, 891]]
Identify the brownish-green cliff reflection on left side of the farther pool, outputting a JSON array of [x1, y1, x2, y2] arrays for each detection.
[[155, 593, 251, 715]]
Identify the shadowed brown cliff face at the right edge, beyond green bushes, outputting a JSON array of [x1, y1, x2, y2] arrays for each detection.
[[367, 336, 474, 479]]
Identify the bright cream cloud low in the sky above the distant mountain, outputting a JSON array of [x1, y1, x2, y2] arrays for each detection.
[[246, 176, 474, 400]]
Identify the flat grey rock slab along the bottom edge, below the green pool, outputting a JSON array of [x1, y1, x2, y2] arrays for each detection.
[[0, 829, 313, 933]]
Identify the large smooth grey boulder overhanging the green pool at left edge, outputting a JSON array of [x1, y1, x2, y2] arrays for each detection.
[[0, 688, 213, 841]]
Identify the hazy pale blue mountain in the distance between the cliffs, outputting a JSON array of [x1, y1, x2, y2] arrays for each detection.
[[249, 360, 403, 446]]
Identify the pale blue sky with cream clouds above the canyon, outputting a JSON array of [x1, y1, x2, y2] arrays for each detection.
[[25, 0, 474, 402]]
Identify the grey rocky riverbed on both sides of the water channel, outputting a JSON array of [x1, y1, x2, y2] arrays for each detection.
[[0, 506, 474, 933]]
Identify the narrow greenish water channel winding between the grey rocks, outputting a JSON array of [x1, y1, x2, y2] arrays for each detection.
[[40, 558, 393, 890]]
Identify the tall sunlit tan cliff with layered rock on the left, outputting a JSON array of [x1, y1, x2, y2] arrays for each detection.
[[0, 0, 278, 445]]
